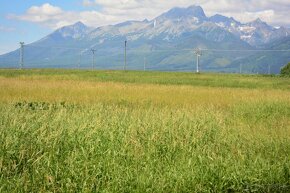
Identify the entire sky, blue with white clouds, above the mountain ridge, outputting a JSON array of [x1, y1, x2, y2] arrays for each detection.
[[0, 0, 290, 55]]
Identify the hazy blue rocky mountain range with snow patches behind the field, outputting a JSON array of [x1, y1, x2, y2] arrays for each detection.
[[0, 6, 290, 73]]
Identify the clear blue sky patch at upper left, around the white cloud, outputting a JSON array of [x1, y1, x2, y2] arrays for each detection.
[[0, 0, 96, 54]]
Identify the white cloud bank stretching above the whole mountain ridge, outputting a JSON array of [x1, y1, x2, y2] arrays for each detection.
[[9, 0, 290, 29]]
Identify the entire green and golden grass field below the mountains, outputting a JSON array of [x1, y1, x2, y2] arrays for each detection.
[[0, 70, 290, 192]]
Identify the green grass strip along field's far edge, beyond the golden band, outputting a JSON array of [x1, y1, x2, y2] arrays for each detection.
[[0, 69, 290, 90]]
